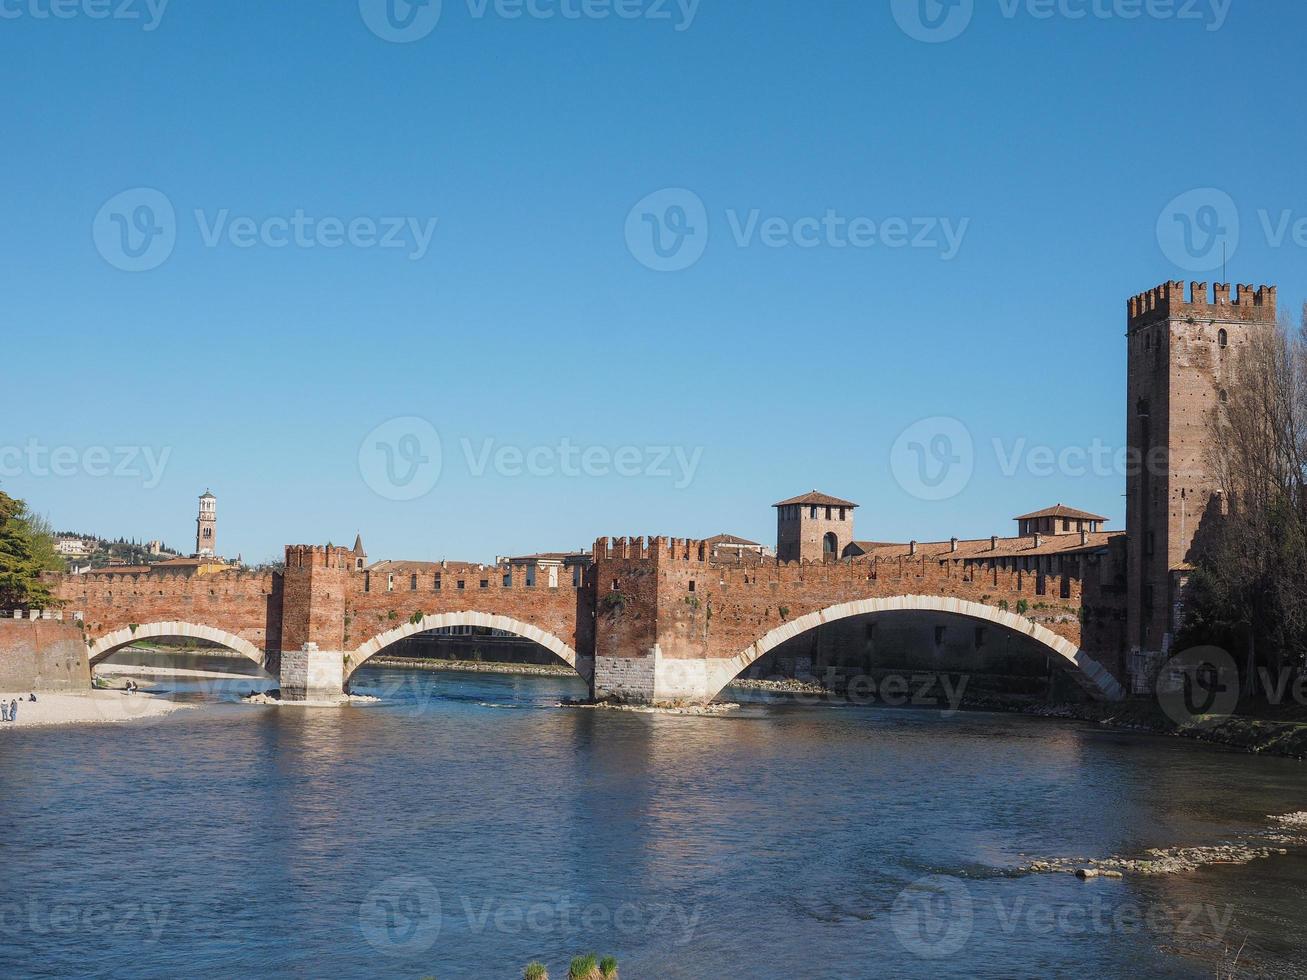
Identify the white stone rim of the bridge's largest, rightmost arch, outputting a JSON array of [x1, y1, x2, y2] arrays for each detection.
[[707, 596, 1125, 700]]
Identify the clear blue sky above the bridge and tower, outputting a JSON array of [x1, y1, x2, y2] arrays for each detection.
[[0, 0, 1307, 561]]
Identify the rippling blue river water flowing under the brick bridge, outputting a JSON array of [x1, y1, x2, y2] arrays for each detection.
[[0, 661, 1307, 980]]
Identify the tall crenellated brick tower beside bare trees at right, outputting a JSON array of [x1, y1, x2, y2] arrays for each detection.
[[1125, 282, 1276, 669]]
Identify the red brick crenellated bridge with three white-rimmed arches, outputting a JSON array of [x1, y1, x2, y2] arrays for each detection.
[[56, 537, 1124, 703]]
